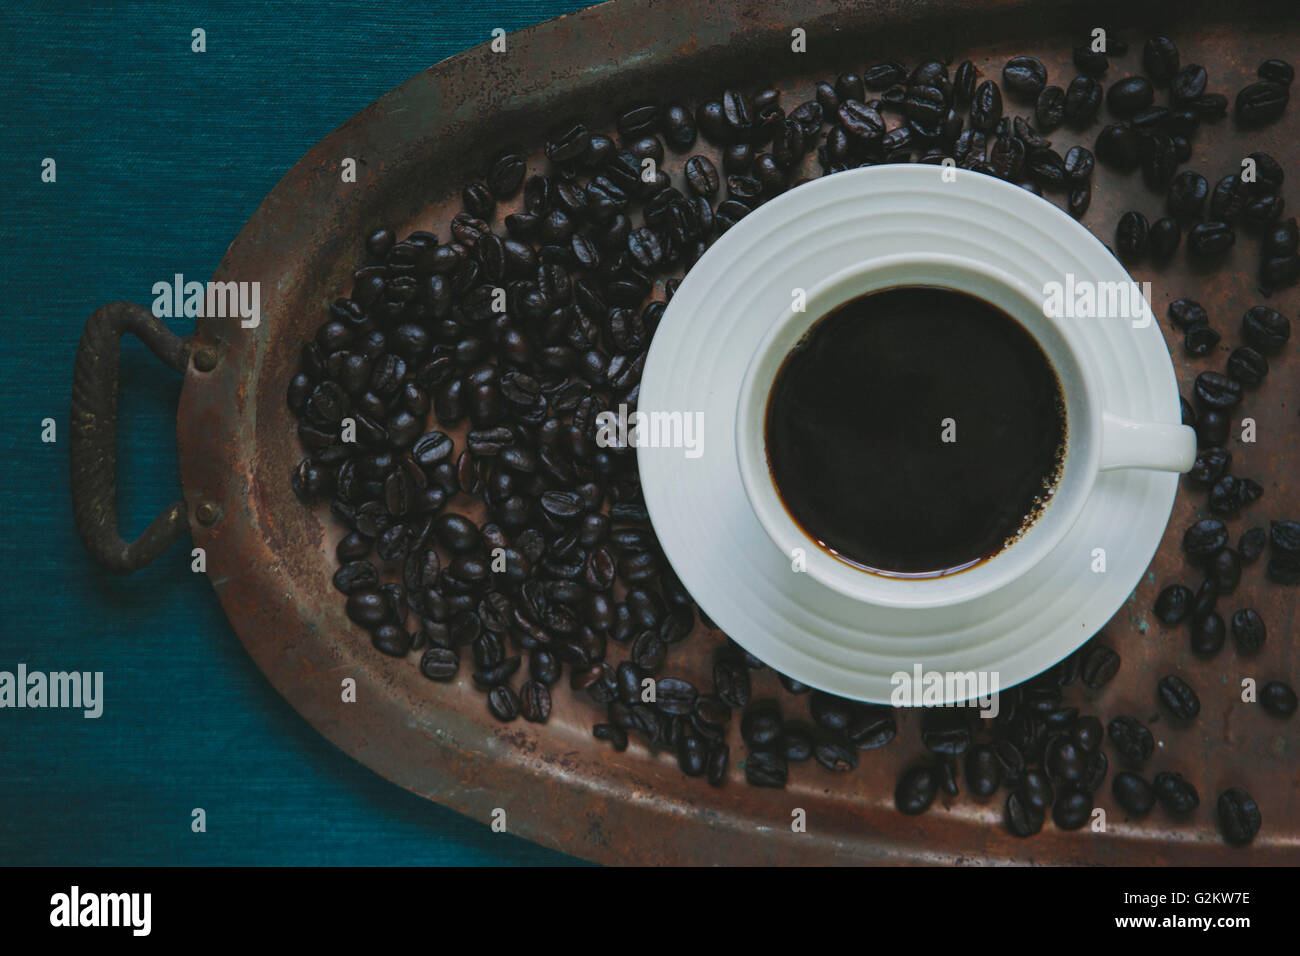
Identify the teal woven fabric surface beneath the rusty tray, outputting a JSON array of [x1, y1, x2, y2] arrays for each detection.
[[0, 0, 586, 865]]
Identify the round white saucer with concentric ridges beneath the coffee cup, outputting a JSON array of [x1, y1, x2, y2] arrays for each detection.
[[637, 165, 1180, 704]]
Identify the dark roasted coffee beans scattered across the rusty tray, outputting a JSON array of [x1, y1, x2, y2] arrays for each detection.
[[289, 36, 1300, 844]]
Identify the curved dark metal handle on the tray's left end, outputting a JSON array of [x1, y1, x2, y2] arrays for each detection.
[[69, 302, 190, 575]]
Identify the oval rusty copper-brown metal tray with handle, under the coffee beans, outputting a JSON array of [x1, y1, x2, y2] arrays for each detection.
[[73, 0, 1300, 865]]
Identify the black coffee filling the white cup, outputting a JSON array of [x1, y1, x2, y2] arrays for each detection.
[[766, 286, 1066, 576]]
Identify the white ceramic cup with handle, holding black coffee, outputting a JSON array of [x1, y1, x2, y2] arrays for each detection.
[[736, 254, 1196, 607]]
